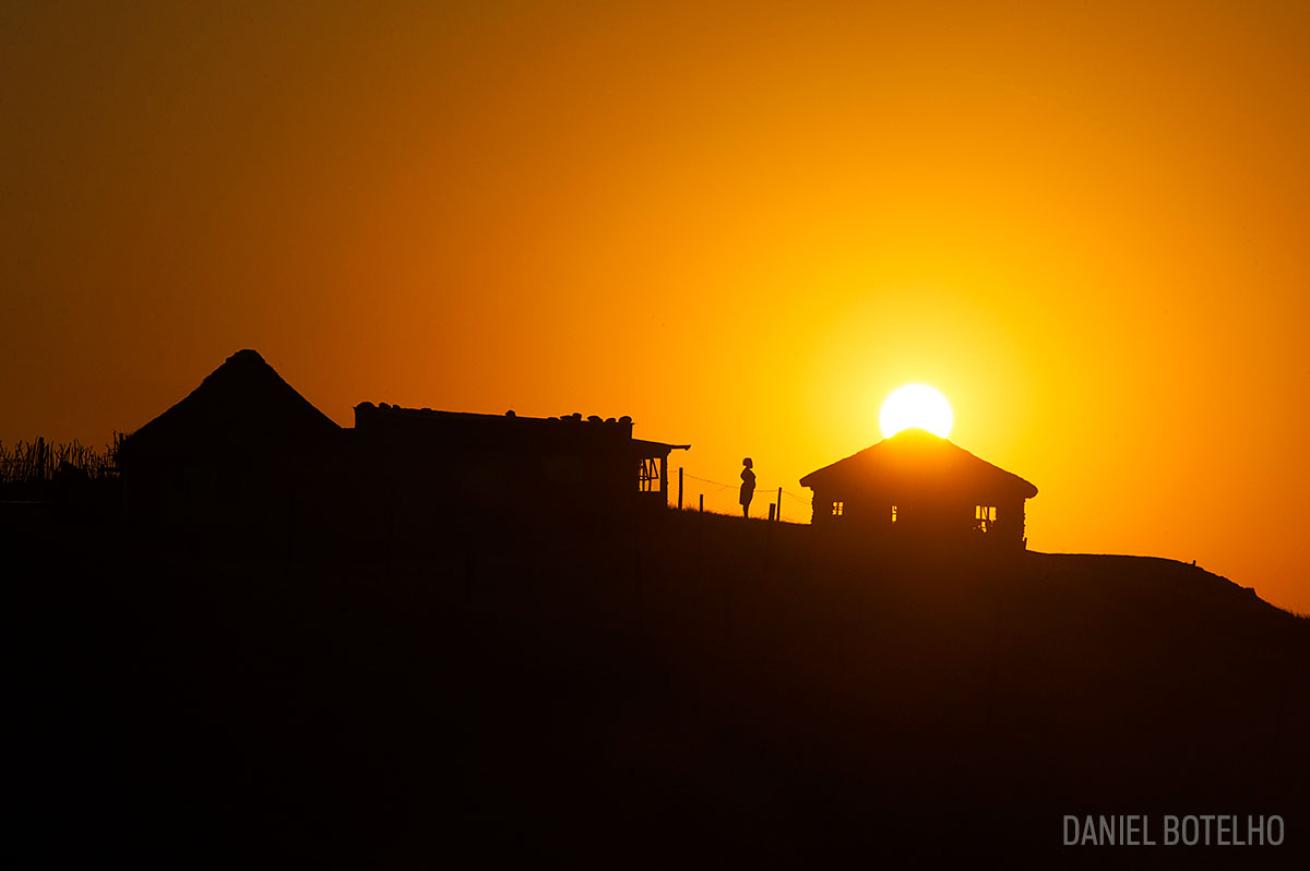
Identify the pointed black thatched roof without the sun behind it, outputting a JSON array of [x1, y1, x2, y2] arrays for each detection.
[[119, 350, 341, 462]]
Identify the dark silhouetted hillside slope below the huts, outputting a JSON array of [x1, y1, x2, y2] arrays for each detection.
[[12, 515, 1310, 867]]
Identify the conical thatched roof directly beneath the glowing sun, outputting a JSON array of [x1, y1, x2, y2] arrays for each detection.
[[800, 430, 1038, 499]]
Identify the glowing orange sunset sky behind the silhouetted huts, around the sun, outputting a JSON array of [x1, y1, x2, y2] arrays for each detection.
[[0, 1, 1310, 612]]
